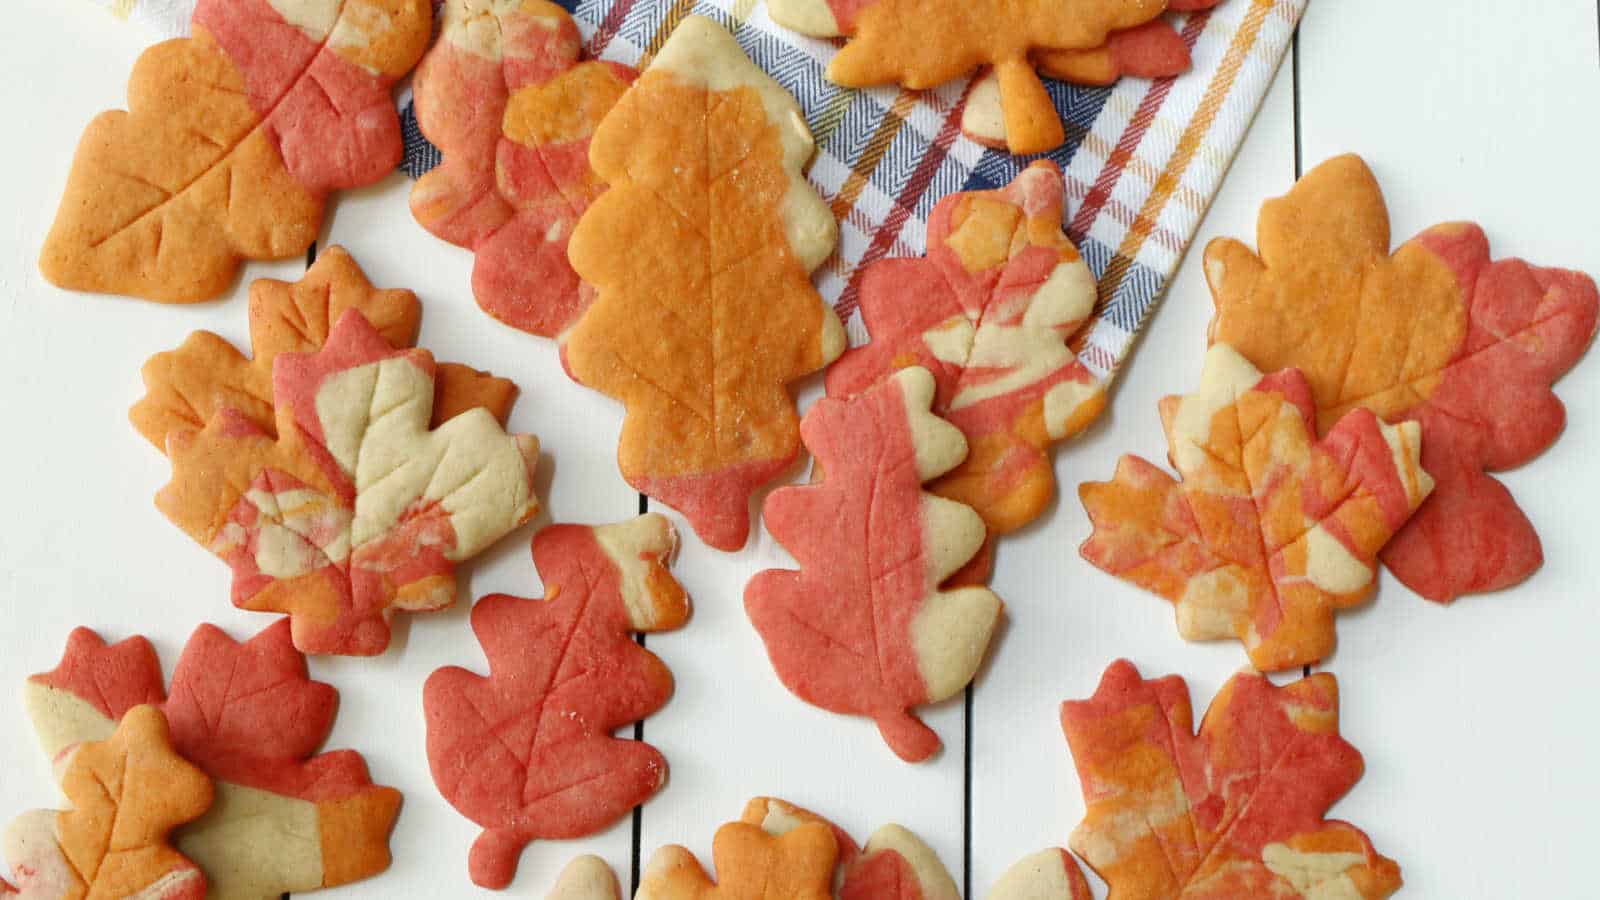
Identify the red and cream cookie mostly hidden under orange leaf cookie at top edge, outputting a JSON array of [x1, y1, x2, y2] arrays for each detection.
[[962, 0, 1221, 151]]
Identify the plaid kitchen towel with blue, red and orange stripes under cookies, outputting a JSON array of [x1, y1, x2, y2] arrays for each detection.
[[84, 0, 1307, 378]]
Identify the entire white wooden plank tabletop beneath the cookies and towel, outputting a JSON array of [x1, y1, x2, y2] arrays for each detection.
[[0, 0, 1600, 900]]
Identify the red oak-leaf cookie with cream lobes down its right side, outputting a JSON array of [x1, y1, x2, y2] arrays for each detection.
[[744, 367, 1000, 762]]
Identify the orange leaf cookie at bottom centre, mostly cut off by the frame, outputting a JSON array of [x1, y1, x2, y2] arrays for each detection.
[[634, 822, 838, 900]]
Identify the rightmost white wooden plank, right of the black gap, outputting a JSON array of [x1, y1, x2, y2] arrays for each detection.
[[1301, 0, 1600, 897]]
